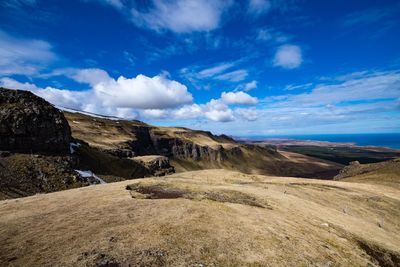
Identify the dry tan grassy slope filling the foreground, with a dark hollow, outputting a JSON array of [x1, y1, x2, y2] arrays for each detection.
[[0, 170, 400, 266]]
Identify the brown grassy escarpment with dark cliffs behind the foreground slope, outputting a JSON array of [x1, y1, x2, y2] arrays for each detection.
[[64, 112, 343, 178]]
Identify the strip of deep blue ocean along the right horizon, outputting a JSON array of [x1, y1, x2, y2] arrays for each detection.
[[241, 133, 400, 149]]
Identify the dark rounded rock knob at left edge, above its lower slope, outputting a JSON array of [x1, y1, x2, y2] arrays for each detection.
[[0, 88, 72, 152]]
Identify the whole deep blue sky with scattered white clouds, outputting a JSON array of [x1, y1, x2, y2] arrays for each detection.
[[0, 0, 400, 136]]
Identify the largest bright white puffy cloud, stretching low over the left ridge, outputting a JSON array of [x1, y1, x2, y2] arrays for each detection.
[[0, 69, 193, 117]]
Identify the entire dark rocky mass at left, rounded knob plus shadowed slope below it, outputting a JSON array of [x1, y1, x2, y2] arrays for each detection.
[[0, 88, 151, 199]]
